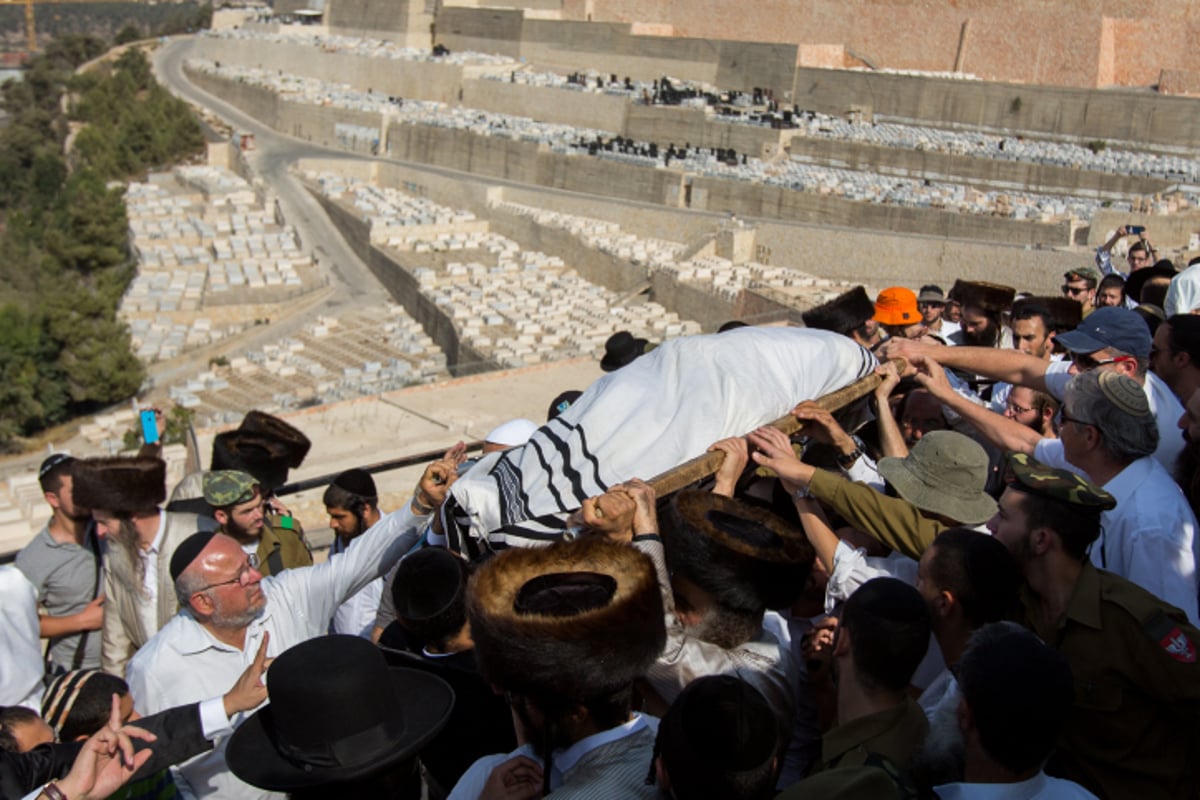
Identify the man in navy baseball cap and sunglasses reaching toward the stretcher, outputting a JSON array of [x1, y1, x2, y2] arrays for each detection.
[[880, 308, 1183, 470]]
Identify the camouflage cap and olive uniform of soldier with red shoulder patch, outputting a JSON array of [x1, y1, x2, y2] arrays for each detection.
[[1009, 455, 1200, 798]]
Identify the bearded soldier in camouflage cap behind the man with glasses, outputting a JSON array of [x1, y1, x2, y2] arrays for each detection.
[[204, 470, 312, 576]]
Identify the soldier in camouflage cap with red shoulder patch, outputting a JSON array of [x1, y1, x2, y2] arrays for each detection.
[[989, 453, 1200, 798]]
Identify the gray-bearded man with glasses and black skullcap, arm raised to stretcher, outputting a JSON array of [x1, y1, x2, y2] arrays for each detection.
[[127, 458, 456, 798]]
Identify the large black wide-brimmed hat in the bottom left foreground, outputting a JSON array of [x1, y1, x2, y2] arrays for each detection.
[[226, 636, 454, 792]]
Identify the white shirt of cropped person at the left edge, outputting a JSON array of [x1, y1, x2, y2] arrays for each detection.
[[0, 564, 43, 714]]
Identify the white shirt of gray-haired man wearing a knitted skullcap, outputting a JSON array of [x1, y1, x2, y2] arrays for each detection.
[[1033, 439, 1200, 625]]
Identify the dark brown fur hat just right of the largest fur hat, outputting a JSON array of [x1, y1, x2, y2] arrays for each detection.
[[662, 491, 816, 613]]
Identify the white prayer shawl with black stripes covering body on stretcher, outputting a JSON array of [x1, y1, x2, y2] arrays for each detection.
[[443, 327, 877, 551]]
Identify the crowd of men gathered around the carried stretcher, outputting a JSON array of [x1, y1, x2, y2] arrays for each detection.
[[0, 229, 1200, 800]]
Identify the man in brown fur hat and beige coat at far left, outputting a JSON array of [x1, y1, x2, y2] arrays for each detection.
[[73, 457, 217, 676]]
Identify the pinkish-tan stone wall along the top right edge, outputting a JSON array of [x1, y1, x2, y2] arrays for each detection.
[[562, 0, 1200, 88]]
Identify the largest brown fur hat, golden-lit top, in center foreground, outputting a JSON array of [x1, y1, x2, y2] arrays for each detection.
[[467, 537, 666, 703]]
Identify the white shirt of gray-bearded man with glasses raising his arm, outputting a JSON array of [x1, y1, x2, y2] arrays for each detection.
[[126, 504, 426, 799]]
